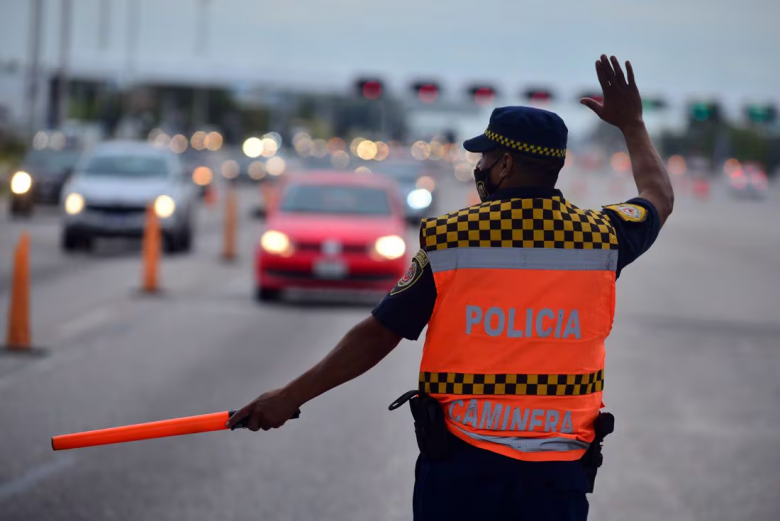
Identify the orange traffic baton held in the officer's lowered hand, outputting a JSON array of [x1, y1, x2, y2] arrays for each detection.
[[51, 409, 301, 450]]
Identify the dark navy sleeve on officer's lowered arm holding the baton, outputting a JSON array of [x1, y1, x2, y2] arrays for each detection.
[[371, 250, 436, 340]]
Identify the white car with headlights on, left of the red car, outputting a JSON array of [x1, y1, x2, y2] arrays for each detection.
[[61, 141, 197, 252]]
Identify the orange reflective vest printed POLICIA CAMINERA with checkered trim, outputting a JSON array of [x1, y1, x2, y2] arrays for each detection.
[[420, 196, 618, 461]]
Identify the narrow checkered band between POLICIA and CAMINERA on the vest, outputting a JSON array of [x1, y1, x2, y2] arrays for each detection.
[[420, 369, 604, 396]]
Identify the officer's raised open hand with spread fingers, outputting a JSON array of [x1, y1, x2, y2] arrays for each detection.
[[580, 54, 642, 130]]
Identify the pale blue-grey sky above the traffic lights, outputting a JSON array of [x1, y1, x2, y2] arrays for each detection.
[[0, 0, 780, 132]]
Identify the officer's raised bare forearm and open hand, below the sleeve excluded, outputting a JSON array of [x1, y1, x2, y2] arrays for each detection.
[[580, 54, 674, 225]]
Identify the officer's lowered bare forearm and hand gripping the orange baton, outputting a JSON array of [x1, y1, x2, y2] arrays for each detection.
[[228, 316, 401, 431]]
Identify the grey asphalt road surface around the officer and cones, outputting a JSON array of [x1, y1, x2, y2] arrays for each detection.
[[0, 168, 780, 521]]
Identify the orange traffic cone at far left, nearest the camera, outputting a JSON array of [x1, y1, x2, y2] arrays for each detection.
[[6, 233, 30, 351]]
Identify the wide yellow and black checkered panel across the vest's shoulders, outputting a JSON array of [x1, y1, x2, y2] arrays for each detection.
[[420, 196, 618, 252]]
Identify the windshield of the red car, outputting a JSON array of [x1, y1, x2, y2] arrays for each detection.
[[281, 184, 390, 215]]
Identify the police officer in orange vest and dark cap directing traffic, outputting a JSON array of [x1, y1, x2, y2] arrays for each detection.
[[229, 55, 674, 521]]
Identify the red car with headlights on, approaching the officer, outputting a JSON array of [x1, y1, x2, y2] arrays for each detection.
[[255, 172, 414, 301]]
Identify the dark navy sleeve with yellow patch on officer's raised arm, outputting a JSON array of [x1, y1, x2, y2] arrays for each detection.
[[604, 197, 661, 276]]
